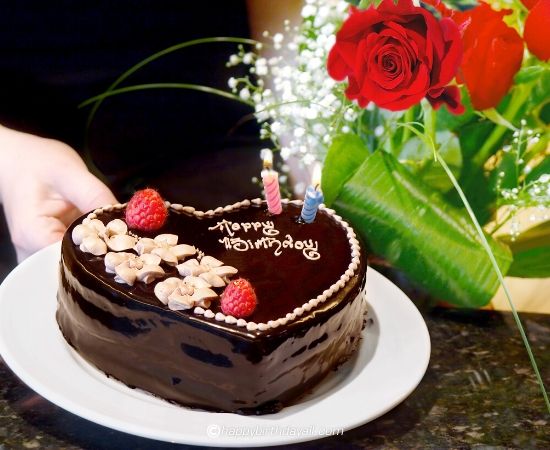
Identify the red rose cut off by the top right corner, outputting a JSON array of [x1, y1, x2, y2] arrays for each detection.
[[523, 0, 550, 61]]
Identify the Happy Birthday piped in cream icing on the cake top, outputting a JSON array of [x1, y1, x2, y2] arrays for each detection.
[[208, 219, 321, 261]]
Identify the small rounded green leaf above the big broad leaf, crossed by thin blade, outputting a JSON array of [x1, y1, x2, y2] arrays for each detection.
[[395, 131, 462, 192]]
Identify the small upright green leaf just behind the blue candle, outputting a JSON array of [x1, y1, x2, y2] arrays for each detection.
[[322, 134, 368, 205]]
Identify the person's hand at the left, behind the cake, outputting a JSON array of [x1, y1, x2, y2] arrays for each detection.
[[0, 126, 117, 262]]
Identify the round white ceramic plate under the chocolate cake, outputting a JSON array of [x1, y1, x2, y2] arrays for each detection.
[[0, 244, 430, 447]]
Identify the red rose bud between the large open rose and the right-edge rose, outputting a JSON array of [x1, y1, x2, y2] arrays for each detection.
[[458, 3, 523, 110]]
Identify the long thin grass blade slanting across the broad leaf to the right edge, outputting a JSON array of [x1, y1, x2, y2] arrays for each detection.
[[424, 108, 550, 413]]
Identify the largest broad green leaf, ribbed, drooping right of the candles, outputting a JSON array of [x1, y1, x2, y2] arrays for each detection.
[[334, 151, 512, 307]]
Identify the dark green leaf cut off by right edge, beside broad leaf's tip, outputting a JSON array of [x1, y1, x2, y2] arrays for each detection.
[[502, 221, 550, 278]]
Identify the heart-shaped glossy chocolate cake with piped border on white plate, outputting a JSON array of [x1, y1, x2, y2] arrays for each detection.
[[57, 199, 366, 414]]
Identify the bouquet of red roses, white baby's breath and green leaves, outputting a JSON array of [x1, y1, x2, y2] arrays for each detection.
[[225, 0, 550, 307]]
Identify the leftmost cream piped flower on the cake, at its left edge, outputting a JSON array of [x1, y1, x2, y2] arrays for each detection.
[[72, 218, 136, 256]]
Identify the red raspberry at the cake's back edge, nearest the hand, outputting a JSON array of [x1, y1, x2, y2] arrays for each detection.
[[126, 189, 168, 231]]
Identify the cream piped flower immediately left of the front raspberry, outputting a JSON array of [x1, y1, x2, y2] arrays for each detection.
[[155, 276, 218, 311]]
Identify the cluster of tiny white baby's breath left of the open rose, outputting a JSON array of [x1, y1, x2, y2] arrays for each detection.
[[228, 0, 357, 170]]
